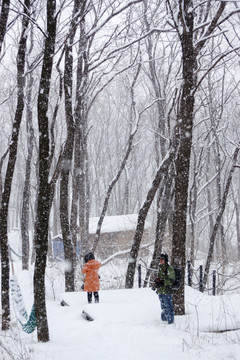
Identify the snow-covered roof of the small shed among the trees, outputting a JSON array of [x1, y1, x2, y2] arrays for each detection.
[[89, 214, 150, 234]]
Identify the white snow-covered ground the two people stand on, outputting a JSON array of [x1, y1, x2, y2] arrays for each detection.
[[0, 271, 240, 360]]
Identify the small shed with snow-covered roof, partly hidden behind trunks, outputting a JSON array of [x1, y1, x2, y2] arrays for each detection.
[[52, 214, 150, 260]]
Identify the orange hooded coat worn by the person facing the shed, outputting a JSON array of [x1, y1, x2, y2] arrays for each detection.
[[82, 259, 101, 292]]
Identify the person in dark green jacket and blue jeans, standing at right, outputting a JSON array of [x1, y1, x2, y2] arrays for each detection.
[[154, 254, 175, 324]]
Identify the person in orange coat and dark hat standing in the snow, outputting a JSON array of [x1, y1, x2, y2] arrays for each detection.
[[82, 252, 101, 303]]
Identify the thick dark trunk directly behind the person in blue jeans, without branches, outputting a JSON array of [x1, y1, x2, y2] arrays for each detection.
[[172, 0, 196, 315]]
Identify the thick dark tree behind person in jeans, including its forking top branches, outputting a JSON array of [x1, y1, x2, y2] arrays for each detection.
[[168, 0, 226, 315]]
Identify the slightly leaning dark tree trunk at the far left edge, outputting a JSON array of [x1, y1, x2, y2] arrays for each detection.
[[0, 0, 30, 330]]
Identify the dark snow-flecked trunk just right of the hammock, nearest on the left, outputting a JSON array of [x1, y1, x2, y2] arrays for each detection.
[[34, 0, 57, 342]]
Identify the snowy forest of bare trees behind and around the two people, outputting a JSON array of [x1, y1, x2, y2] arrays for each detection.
[[0, 0, 240, 342]]
